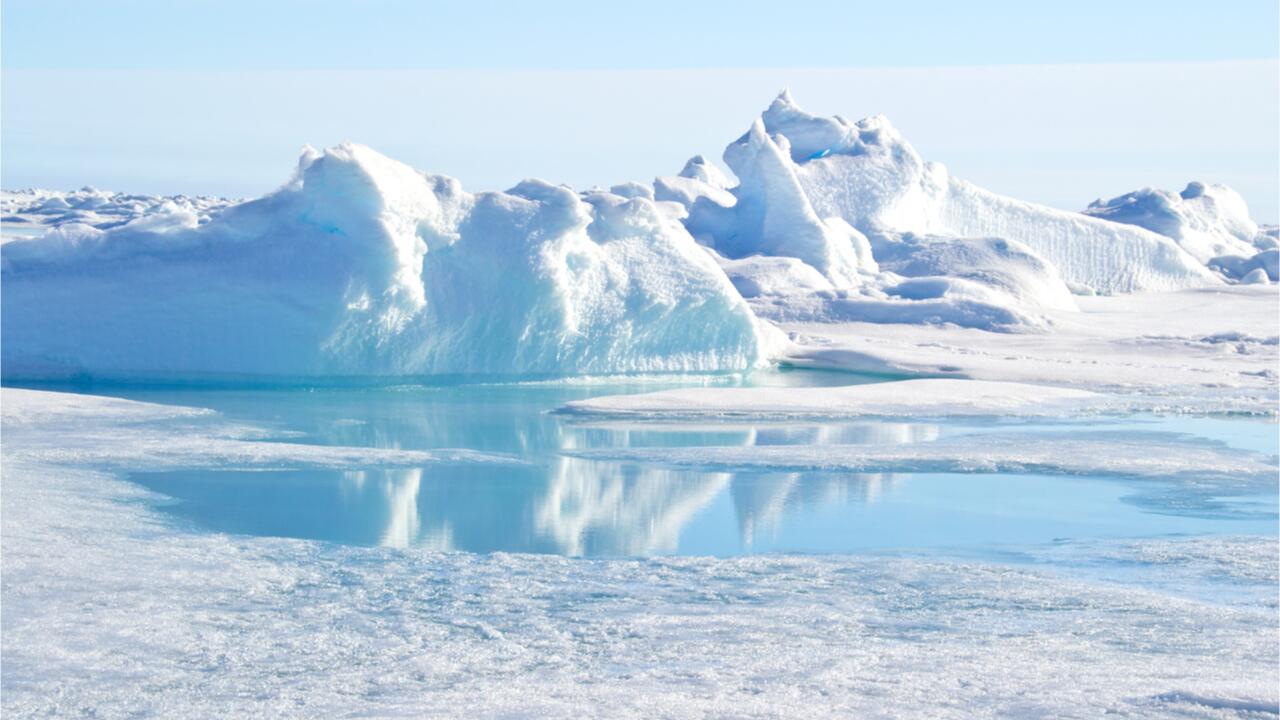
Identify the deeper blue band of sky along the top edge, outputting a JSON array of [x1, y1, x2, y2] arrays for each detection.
[[3, 0, 1280, 69]]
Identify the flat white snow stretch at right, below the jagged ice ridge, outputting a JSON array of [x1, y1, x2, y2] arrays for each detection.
[[783, 286, 1280, 415]]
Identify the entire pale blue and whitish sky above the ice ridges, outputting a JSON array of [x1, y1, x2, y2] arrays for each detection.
[[0, 0, 1280, 222]]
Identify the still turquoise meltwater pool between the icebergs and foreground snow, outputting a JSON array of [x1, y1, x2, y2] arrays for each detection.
[[87, 372, 1277, 556]]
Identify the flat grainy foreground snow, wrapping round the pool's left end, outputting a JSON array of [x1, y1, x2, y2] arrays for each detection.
[[0, 391, 1280, 717]]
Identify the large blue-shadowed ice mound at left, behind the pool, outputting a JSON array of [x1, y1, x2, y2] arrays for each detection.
[[3, 145, 772, 377]]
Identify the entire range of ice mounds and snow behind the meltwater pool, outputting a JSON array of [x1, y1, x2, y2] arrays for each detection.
[[3, 92, 1280, 399]]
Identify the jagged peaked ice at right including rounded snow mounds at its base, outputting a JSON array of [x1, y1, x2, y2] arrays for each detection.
[[654, 91, 1274, 333]]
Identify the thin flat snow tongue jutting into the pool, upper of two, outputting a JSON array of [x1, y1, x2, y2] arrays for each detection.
[[562, 378, 1108, 419]]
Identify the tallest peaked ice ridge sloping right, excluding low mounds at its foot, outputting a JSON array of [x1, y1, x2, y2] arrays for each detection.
[[680, 91, 1220, 293]]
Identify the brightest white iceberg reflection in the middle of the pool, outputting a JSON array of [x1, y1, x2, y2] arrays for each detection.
[[534, 457, 730, 555]]
